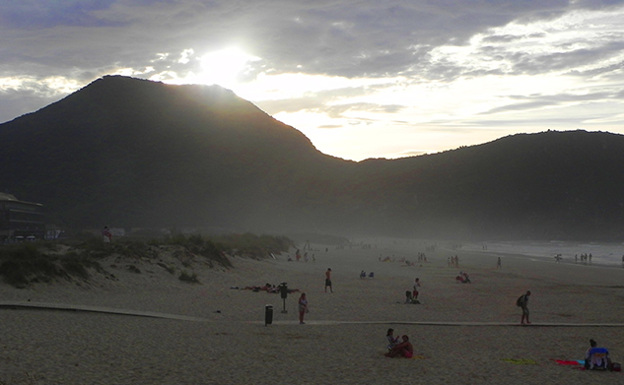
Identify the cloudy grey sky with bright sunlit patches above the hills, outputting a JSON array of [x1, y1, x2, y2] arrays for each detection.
[[0, 0, 624, 161]]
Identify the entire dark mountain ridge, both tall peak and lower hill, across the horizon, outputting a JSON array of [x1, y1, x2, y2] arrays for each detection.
[[0, 76, 624, 239]]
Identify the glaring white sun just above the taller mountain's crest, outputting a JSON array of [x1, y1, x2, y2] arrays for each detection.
[[198, 47, 260, 88]]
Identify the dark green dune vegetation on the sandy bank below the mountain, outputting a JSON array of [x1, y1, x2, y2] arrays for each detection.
[[0, 233, 293, 288]]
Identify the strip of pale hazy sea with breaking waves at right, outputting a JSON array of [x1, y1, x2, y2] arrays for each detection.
[[461, 241, 624, 267]]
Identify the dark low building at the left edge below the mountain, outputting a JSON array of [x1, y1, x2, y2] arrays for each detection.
[[0, 192, 45, 242]]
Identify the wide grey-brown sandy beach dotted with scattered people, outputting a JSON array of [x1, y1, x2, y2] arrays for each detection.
[[0, 239, 624, 384]]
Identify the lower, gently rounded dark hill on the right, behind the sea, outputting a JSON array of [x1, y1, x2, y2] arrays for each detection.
[[348, 131, 624, 239]]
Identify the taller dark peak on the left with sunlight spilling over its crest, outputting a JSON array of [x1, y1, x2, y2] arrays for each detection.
[[0, 76, 349, 228]]
